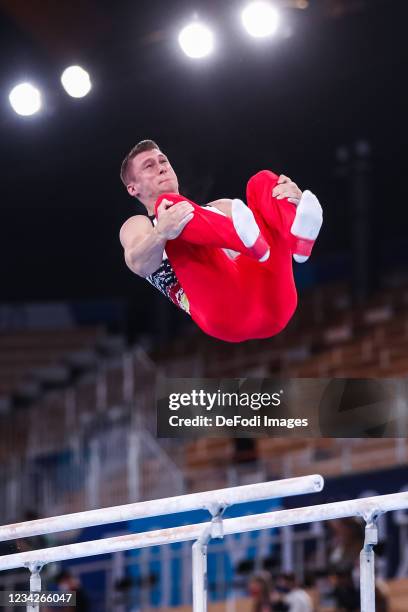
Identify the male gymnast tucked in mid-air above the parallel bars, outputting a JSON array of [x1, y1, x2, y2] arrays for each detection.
[[120, 140, 323, 342]]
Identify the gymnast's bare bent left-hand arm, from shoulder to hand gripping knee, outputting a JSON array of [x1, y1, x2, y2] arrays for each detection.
[[119, 200, 193, 277]]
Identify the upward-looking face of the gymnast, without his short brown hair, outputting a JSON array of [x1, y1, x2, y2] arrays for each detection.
[[127, 149, 178, 204]]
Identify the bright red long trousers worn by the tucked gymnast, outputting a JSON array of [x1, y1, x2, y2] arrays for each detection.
[[156, 170, 297, 342]]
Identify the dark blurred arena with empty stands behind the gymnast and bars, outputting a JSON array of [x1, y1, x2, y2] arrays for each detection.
[[0, 0, 408, 612]]
